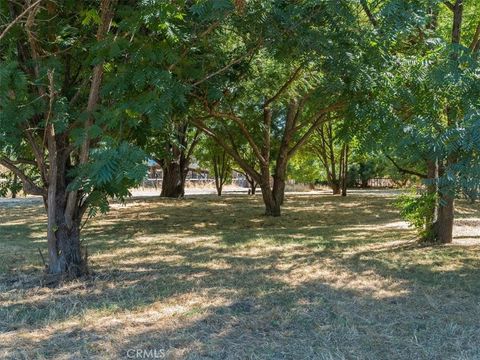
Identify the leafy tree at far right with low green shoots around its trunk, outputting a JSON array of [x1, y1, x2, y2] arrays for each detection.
[[359, 0, 480, 243]]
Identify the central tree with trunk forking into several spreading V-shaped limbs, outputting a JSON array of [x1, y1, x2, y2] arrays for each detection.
[[189, 1, 374, 216]]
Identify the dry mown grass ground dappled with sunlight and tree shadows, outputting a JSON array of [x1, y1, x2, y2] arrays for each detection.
[[0, 192, 480, 360]]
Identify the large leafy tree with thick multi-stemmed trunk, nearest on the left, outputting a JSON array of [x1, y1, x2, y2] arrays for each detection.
[[0, 0, 145, 277]]
